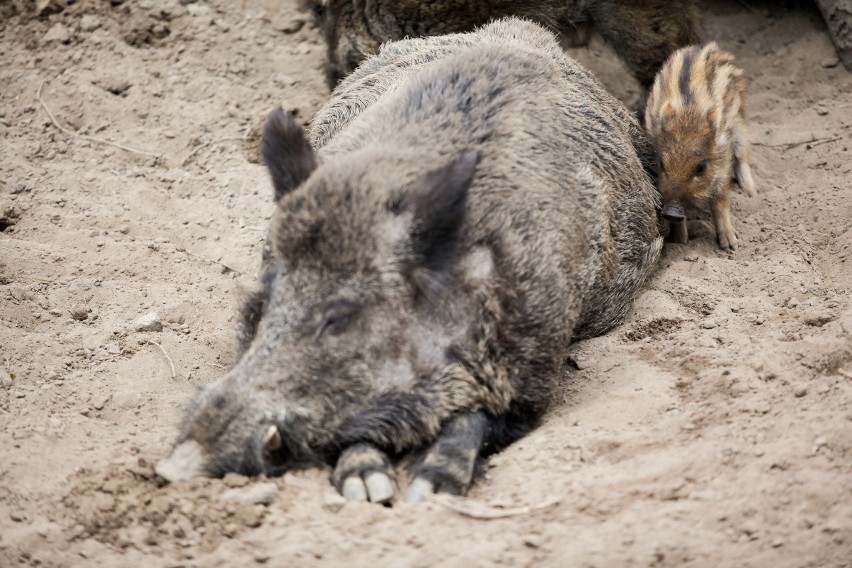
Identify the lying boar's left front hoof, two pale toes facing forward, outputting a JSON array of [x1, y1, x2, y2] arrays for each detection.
[[331, 444, 396, 503]]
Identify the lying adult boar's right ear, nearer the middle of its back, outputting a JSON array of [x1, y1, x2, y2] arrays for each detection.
[[395, 150, 479, 271]]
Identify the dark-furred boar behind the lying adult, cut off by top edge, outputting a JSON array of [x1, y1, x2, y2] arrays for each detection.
[[303, 0, 700, 88]]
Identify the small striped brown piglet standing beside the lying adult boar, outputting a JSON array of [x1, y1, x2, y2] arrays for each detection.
[[645, 42, 757, 251]]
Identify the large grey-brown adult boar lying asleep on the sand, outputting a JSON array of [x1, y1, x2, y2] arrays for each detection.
[[157, 19, 661, 501]]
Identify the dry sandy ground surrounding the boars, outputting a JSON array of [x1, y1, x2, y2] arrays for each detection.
[[0, 0, 852, 567]]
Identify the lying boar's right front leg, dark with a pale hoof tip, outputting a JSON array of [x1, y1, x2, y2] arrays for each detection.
[[405, 412, 488, 503]]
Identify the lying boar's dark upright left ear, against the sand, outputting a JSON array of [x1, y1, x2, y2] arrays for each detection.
[[261, 107, 317, 201]]
